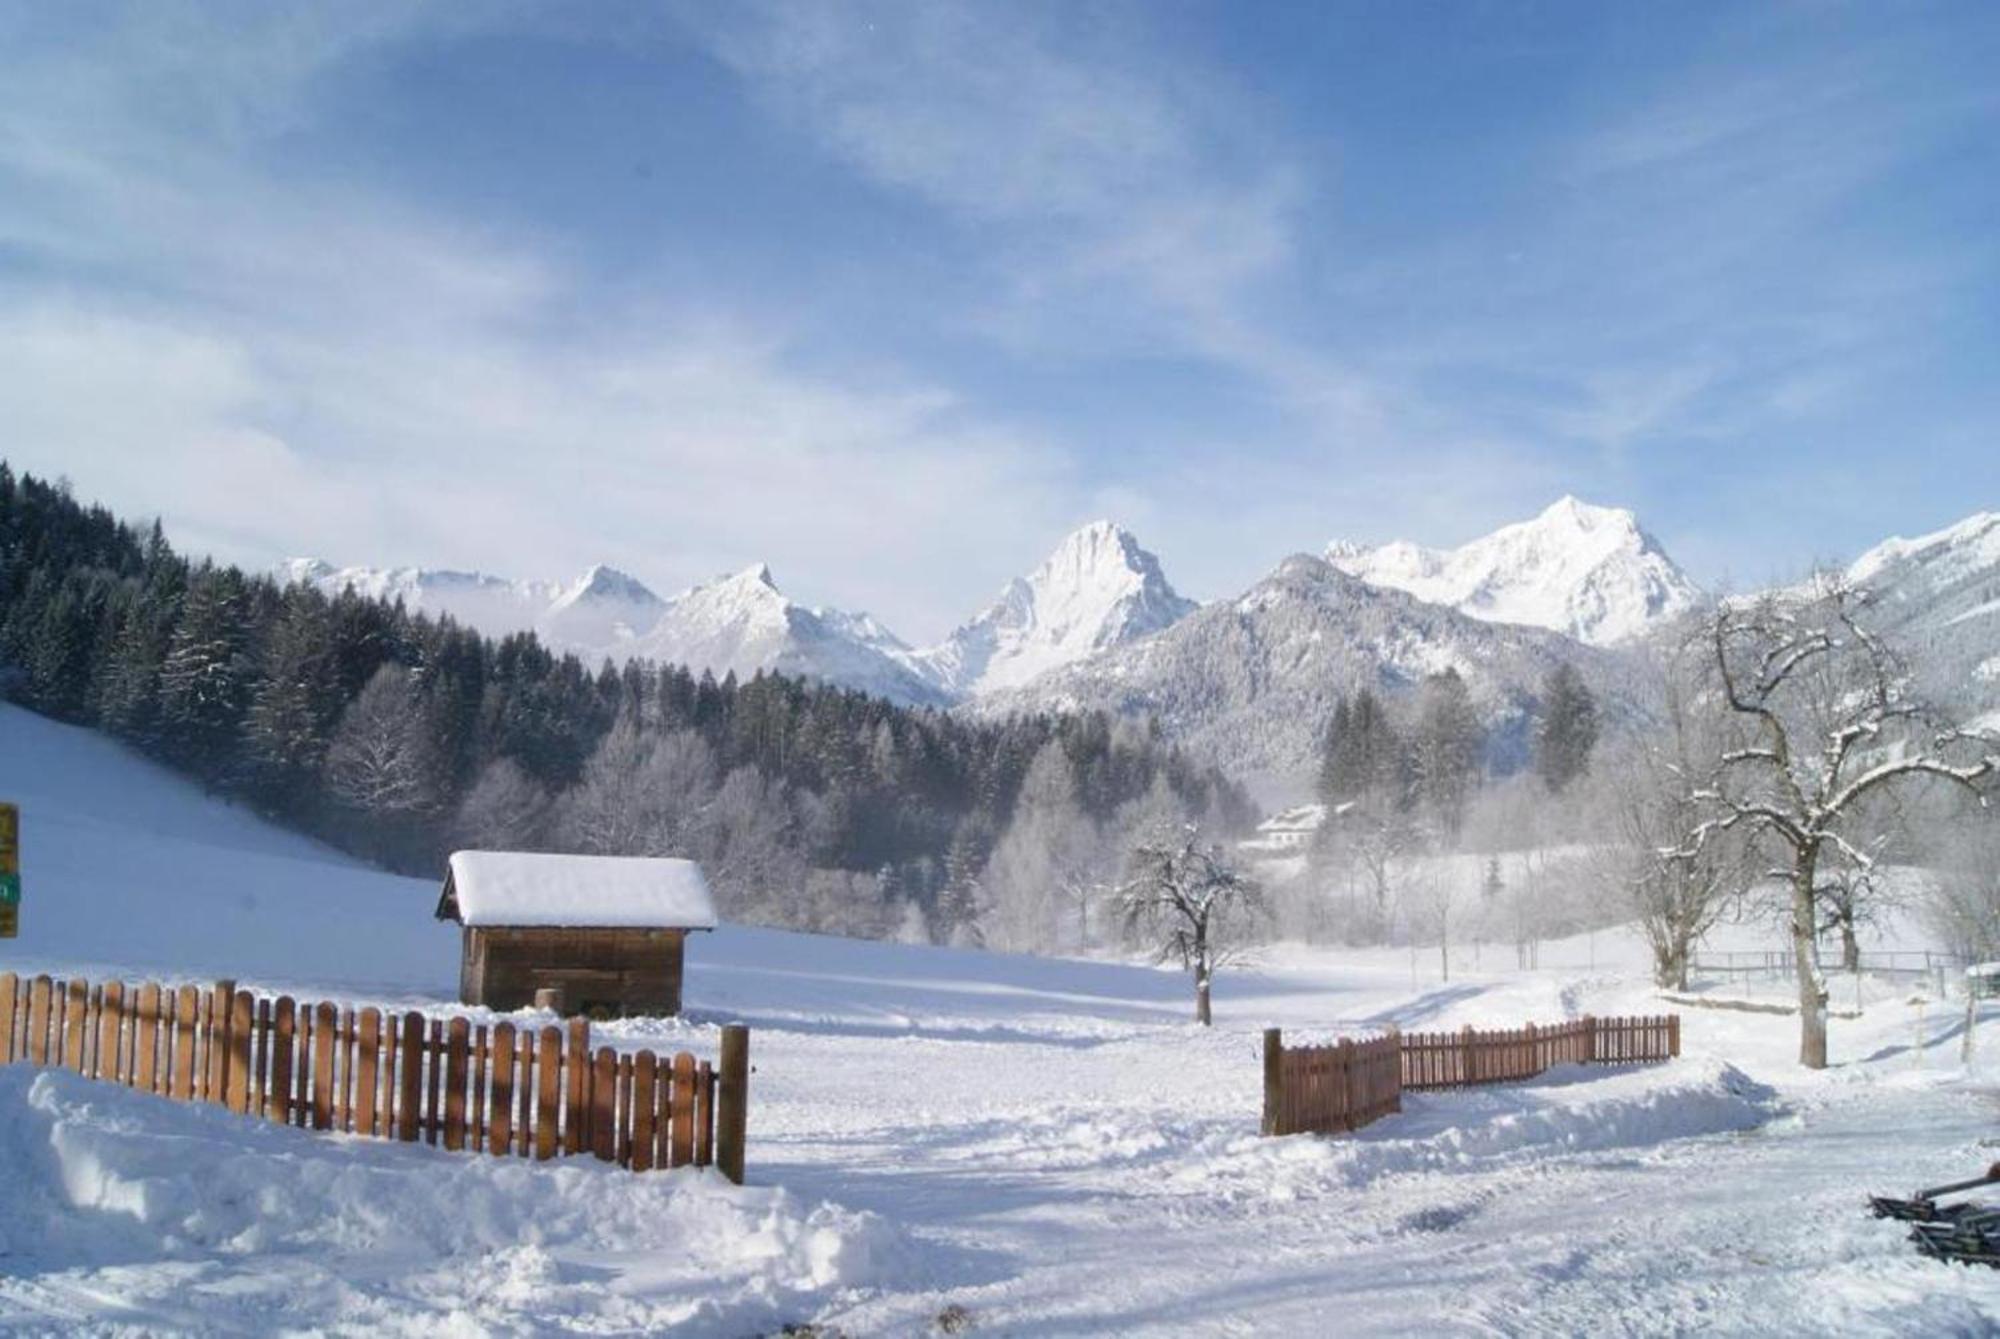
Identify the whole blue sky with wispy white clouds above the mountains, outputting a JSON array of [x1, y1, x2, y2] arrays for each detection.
[[0, 0, 2000, 642]]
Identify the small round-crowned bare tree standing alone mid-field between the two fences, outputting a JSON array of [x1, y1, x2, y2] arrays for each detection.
[[1118, 823, 1264, 1027]]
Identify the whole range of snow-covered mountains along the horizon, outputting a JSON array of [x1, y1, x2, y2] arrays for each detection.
[[282, 498, 2000, 795]]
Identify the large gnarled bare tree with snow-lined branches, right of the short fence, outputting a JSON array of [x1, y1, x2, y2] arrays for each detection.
[[1688, 574, 2000, 1069]]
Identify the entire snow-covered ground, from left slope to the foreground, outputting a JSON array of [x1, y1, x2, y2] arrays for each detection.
[[0, 707, 2000, 1335]]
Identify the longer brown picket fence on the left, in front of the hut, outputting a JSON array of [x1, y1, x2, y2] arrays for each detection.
[[0, 971, 750, 1183]]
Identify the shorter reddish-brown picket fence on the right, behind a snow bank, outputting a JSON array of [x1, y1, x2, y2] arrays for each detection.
[[1262, 1013, 1680, 1135]]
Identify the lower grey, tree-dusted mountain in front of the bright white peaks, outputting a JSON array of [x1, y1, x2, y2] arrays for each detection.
[[980, 554, 1634, 799]]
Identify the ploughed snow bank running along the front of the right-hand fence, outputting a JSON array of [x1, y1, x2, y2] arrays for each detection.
[[1176, 1061, 1778, 1199]]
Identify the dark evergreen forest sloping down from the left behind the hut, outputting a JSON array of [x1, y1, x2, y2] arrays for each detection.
[[0, 462, 1252, 947]]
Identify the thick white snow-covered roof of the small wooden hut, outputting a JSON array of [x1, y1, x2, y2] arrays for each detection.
[[438, 851, 716, 929]]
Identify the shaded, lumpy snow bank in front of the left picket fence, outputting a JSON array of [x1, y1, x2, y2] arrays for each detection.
[[0, 1065, 906, 1333]]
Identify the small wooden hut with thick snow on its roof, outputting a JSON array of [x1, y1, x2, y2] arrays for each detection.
[[438, 851, 716, 1015]]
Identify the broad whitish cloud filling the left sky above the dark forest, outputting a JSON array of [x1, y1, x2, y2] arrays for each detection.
[[0, 2, 1096, 632]]
